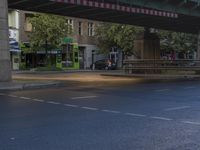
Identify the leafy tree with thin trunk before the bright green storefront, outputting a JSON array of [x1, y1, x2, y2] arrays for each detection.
[[29, 14, 71, 64]]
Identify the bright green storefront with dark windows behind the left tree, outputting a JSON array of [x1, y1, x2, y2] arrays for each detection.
[[21, 38, 80, 70]]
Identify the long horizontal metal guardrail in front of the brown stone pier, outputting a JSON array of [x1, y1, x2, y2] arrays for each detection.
[[124, 59, 200, 74]]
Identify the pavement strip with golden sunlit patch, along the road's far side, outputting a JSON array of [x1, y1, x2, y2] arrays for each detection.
[[0, 70, 200, 91]]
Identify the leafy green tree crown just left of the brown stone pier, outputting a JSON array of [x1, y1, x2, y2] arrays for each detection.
[[96, 23, 143, 54]]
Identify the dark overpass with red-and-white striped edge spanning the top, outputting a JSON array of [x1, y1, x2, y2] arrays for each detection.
[[8, 0, 200, 33]]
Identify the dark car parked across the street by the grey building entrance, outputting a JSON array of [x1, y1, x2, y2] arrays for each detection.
[[90, 59, 117, 70]]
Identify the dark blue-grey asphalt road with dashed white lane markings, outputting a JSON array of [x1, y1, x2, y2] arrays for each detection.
[[0, 77, 200, 150]]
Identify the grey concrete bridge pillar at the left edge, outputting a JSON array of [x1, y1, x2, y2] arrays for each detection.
[[0, 0, 11, 82]]
